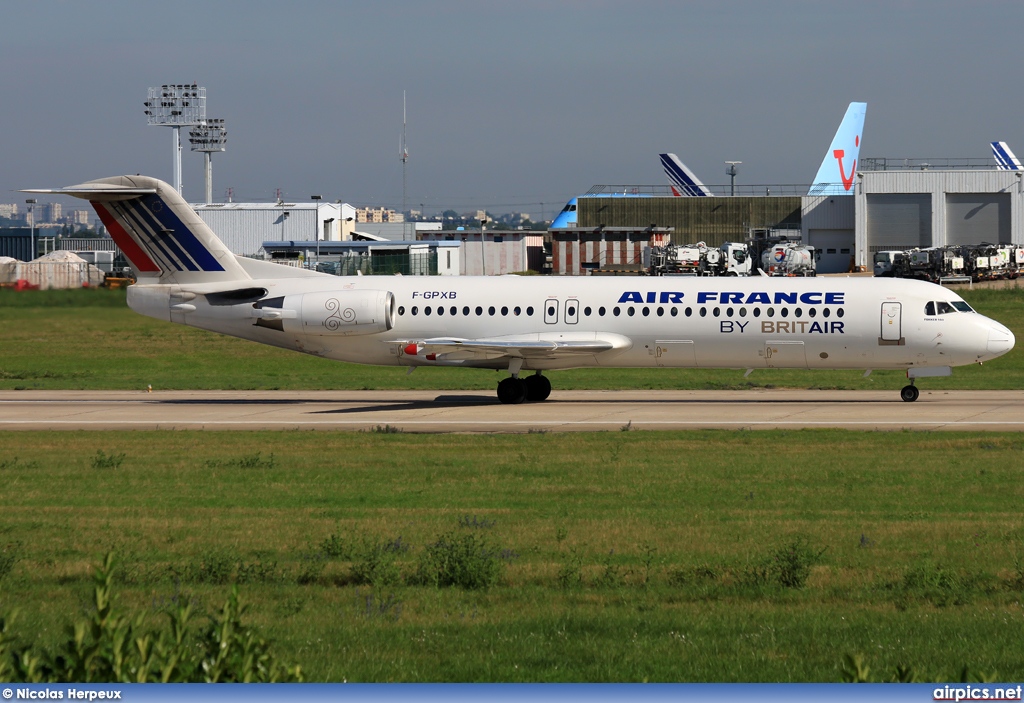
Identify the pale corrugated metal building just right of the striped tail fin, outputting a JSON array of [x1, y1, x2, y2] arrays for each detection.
[[191, 202, 355, 256]]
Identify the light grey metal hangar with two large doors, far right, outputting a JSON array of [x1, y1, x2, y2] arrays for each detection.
[[855, 168, 1024, 266]]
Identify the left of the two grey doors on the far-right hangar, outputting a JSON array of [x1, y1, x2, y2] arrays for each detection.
[[866, 192, 932, 254]]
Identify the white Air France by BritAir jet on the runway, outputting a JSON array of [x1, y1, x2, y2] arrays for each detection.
[[27, 176, 1014, 403]]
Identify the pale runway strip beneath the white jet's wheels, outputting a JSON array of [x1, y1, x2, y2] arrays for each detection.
[[0, 388, 1024, 433]]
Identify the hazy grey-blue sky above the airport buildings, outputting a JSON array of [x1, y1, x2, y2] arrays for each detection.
[[0, 0, 1024, 217]]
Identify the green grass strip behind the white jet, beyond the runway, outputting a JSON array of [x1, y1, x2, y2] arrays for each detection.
[[0, 288, 1024, 391]]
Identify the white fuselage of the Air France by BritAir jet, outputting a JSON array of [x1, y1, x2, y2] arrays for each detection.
[[129, 275, 1013, 370]]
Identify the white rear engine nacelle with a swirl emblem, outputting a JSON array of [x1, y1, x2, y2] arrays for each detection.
[[284, 291, 395, 337]]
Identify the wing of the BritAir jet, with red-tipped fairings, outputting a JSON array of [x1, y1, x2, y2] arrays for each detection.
[[395, 335, 633, 361]]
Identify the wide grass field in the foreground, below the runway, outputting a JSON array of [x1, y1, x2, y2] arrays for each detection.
[[0, 431, 1024, 682]]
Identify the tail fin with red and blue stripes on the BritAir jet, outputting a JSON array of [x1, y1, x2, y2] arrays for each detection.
[[23, 176, 251, 283]]
